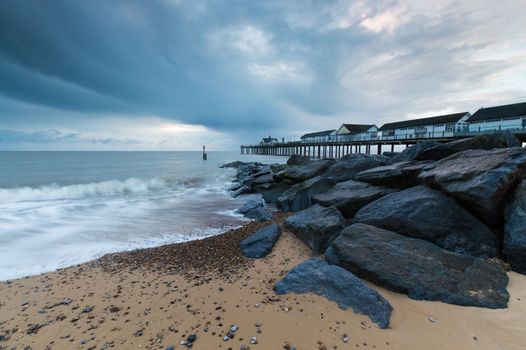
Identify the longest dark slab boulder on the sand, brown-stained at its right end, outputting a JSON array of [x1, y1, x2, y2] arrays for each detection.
[[325, 224, 509, 309]]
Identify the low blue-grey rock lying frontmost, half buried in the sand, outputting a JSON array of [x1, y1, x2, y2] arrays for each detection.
[[274, 258, 392, 329]]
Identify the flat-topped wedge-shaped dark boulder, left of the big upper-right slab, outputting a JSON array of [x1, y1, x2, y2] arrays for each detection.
[[354, 161, 431, 188]]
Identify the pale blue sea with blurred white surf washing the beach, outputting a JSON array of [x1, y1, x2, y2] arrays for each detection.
[[0, 152, 286, 280]]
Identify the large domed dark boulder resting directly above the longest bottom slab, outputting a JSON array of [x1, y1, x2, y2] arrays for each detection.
[[353, 186, 497, 257]]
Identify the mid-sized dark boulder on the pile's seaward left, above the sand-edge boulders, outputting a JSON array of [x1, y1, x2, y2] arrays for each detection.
[[277, 176, 335, 212]]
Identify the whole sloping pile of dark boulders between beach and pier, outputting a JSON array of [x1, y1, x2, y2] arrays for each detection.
[[226, 132, 526, 326]]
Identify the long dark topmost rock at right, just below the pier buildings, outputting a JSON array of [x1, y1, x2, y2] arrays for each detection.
[[415, 131, 521, 160]]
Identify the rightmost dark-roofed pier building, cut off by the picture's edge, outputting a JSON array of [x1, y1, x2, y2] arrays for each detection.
[[468, 102, 526, 132]]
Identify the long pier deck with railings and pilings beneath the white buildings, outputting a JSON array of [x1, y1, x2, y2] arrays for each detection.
[[240, 127, 526, 159]]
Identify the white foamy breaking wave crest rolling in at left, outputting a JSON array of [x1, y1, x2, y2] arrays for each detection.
[[0, 178, 192, 203]]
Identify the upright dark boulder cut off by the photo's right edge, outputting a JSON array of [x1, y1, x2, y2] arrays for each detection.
[[504, 180, 526, 274]]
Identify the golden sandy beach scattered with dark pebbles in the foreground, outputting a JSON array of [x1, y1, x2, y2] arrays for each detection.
[[0, 214, 526, 350]]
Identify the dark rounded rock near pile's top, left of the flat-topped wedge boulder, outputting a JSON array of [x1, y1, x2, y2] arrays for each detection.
[[323, 153, 385, 182]]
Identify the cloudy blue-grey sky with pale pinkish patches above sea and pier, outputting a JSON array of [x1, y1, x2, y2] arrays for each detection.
[[0, 0, 526, 150]]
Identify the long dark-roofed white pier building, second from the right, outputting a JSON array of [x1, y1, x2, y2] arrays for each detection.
[[379, 112, 471, 140]]
